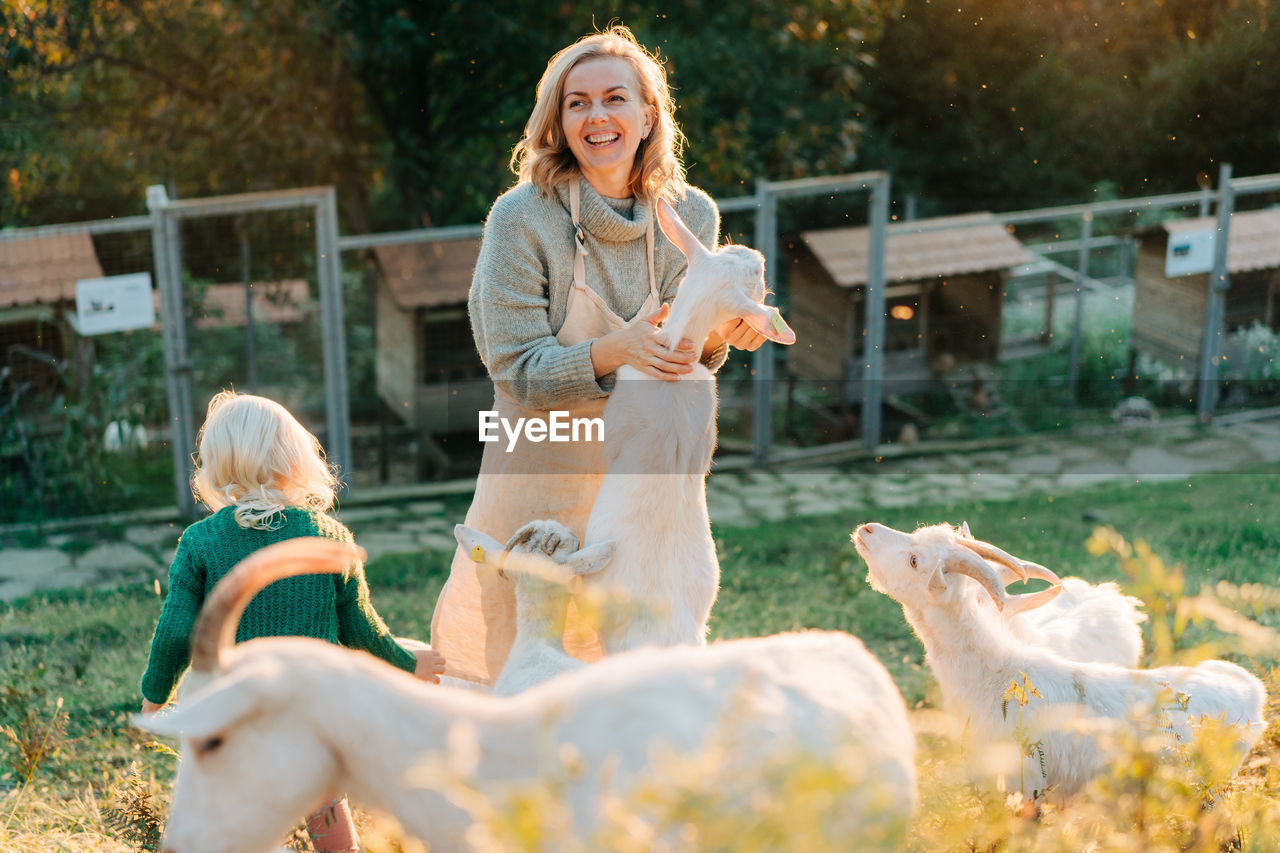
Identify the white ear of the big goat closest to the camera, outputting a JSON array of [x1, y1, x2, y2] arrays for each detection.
[[131, 667, 277, 739]]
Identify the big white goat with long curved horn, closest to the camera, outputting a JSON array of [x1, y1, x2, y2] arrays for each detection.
[[134, 539, 916, 853]]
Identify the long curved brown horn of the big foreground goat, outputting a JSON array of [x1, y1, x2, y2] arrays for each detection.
[[191, 537, 365, 674]]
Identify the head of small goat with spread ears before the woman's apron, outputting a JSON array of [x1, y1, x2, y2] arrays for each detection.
[[453, 520, 617, 584]]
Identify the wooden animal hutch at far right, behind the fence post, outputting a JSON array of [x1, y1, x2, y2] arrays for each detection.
[[1129, 209, 1280, 369]]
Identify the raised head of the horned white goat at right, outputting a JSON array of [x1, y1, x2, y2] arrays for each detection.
[[850, 524, 1061, 613]]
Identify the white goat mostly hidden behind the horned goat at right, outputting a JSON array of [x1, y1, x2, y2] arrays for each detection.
[[960, 523, 1147, 667]]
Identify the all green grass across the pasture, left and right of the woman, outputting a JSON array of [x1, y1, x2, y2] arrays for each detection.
[[0, 465, 1280, 850]]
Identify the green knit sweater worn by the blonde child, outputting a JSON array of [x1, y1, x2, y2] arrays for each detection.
[[142, 506, 417, 704]]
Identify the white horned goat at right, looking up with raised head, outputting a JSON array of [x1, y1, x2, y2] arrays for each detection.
[[852, 524, 1266, 797]]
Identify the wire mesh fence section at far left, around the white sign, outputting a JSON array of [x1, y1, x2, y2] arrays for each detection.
[[0, 219, 173, 521]]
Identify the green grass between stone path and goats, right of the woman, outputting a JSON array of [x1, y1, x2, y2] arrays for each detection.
[[712, 466, 1280, 702]]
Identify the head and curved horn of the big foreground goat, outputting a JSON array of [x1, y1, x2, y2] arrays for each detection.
[[133, 538, 365, 853]]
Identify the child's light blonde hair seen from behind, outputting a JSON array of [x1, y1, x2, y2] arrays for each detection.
[[191, 391, 338, 529]]
